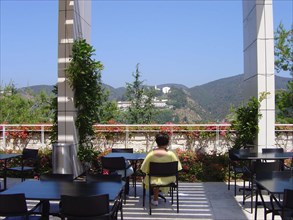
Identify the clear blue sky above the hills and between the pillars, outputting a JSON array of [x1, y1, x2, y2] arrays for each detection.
[[0, 0, 293, 88]]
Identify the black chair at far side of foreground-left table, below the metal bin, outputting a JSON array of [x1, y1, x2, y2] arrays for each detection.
[[33, 173, 74, 217]]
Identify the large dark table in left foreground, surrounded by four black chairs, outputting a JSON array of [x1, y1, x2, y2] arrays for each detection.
[[0, 180, 124, 219]]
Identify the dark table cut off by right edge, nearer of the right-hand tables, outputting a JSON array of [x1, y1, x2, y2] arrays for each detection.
[[255, 171, 293, 219]]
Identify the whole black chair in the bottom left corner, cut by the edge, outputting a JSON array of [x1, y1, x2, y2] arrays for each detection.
[[0, 193, 41, 220]]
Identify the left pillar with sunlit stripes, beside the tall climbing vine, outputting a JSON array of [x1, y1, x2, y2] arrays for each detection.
[[57, 0, 91, 176]]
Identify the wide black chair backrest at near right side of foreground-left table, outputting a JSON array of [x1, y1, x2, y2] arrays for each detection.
[[60, 194, 110, 219]]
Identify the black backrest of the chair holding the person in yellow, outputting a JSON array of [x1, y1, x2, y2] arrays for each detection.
[[149, 161, 178, 177]]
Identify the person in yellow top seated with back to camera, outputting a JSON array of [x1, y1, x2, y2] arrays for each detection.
[[141, 133, 182, 205]]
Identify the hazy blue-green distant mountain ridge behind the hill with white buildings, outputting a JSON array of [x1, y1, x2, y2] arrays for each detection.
[[20, 74, 291, 121]]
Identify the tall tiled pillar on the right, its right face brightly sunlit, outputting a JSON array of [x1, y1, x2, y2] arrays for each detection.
[[243, 0, 275, 152]]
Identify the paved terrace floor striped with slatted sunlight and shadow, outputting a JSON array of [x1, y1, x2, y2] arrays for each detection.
[[4, 179, 281, 220]]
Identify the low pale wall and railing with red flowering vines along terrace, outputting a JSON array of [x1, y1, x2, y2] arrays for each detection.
[[0, 123, 293, 152]]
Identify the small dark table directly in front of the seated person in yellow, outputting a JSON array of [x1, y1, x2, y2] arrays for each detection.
[[105, 152, 146, 197]]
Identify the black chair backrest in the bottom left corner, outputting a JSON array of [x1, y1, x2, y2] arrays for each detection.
[[0, 193, 27, 216]]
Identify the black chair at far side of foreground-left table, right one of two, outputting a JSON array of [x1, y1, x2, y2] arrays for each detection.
[[86, 174, 124, 220]]
